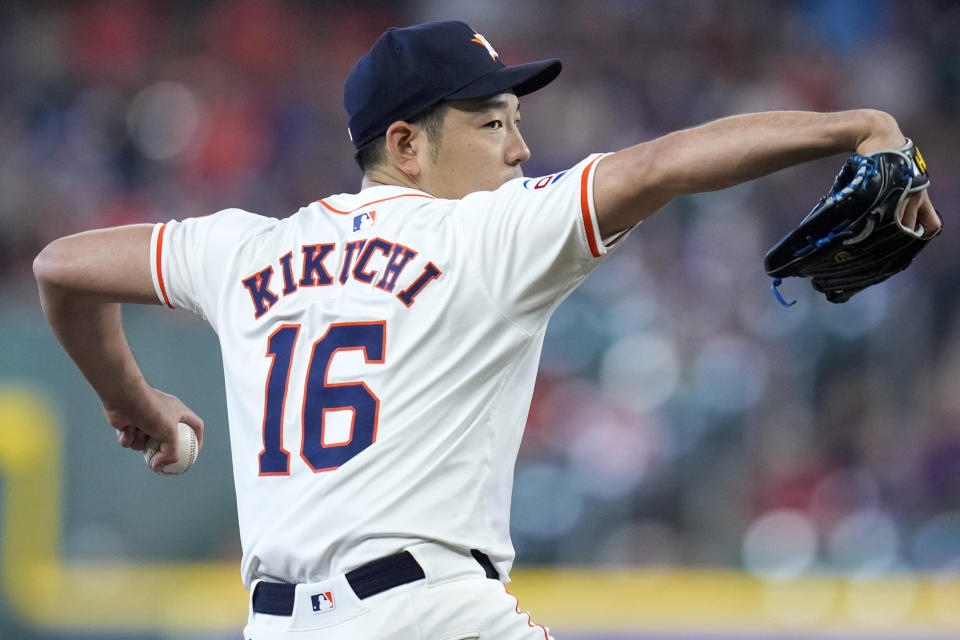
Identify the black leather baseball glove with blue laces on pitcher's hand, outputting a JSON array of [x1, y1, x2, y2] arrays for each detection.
[[763, 140, 940, 306]]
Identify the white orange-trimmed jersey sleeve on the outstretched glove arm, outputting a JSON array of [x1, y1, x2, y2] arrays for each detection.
[[456, 154, 629, 331]]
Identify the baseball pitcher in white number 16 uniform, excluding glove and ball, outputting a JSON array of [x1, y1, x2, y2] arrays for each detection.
[[34, 22, 940, 640]]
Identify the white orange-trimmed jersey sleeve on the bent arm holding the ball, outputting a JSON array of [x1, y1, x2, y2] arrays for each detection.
[[150, 209, 277, 329]]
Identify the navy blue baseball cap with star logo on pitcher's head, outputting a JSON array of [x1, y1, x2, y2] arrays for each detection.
[[343, 21, 561, 149]]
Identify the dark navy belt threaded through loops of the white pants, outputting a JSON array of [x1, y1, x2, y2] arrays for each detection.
[[253, 549, 500, 616]]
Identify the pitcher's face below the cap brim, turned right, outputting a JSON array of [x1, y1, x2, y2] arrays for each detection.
[[420, 93, 530, 198]]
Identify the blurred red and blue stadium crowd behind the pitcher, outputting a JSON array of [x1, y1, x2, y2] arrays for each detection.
[[0, 0, 960, 577]]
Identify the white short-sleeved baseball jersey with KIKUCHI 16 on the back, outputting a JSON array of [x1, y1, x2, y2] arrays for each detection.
[[151, 155, 621, 587]]
